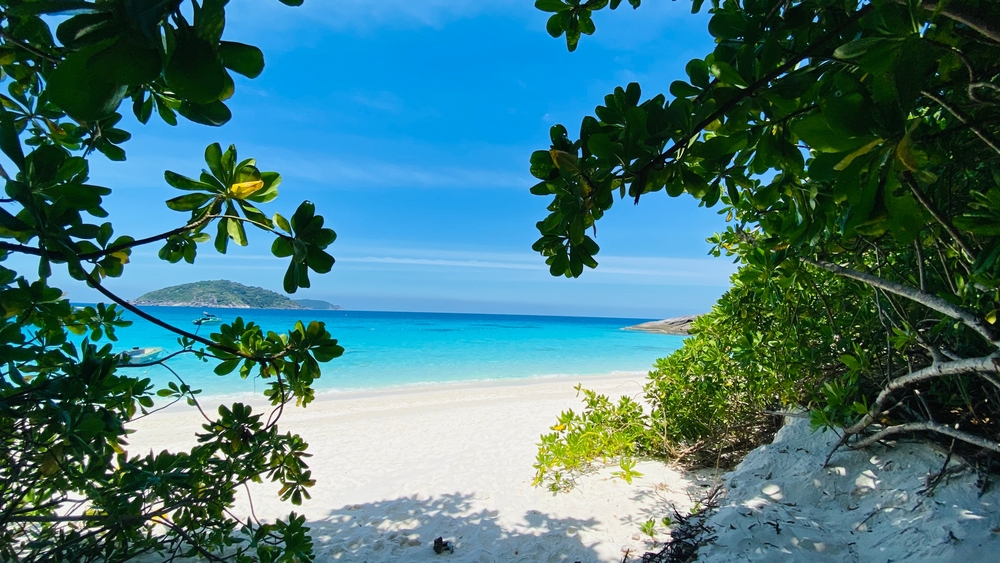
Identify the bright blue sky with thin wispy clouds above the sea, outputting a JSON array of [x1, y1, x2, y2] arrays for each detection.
[[15, 0, 734, 318]]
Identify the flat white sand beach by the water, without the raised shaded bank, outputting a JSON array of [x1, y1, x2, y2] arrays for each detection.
[[129, 376, 704, 563]]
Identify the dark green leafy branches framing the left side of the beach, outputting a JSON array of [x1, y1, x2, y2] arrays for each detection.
[[0, 0, 343, 562]]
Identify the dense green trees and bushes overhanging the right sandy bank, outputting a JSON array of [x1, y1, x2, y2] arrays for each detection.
[[531, 0, 1000, 479]]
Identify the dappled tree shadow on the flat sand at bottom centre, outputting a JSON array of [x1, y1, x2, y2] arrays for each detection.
[[308, 493, 600, 563]]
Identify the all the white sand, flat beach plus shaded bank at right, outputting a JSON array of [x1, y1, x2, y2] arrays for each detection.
[[130, 376, 1000, 563]]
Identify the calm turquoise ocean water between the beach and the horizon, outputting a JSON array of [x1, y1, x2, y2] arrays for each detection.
[[109, 307, 682, 395]]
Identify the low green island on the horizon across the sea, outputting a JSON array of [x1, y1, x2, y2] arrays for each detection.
[[131, 280, 343, 310]]
